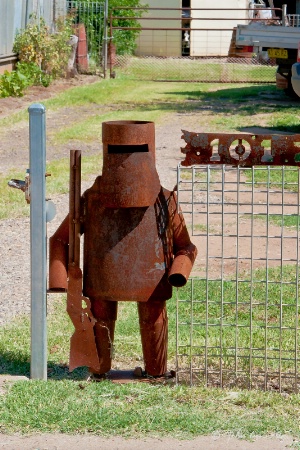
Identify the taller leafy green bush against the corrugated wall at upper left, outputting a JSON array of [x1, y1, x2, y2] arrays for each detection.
[[13, 15, 72, 78]]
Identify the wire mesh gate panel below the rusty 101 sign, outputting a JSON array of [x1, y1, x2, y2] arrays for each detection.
[[176, 135, 300, 392]]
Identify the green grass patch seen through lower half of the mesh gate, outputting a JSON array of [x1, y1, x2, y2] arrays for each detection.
[[178, 266, 300, 373]]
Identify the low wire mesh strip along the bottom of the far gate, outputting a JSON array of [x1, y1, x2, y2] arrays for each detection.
[[113, 55, 276, 83]]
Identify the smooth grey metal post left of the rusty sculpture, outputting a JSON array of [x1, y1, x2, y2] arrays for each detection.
[[28, 103, 47, 380]]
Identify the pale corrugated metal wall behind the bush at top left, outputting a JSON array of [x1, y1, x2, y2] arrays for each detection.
[[0, 0, 66, 58]]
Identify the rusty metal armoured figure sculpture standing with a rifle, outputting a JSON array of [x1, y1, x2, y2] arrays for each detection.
[[49, 121, 197, 377]]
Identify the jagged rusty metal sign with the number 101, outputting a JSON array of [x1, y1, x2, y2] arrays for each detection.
[[181, 130, 300, 167]]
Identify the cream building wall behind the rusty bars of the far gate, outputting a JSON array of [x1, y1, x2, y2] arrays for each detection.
[[136, 0, 250, 57]]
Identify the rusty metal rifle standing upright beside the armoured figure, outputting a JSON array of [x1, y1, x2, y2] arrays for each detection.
[[67, 150, 100, 372]]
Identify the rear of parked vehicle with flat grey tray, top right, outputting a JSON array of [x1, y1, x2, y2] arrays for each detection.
[[236, 0, 300, 97]]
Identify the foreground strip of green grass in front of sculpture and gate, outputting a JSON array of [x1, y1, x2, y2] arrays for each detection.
[[0, 381, 300, 439]]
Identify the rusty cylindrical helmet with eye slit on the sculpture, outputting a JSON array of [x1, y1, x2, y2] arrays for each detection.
[[100, 120, 160, 208]]
